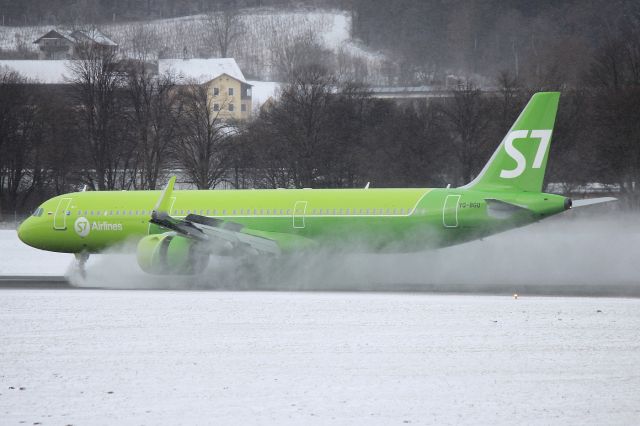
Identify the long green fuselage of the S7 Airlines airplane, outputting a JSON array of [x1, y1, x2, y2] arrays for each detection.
[[19, 188, 567, 253]]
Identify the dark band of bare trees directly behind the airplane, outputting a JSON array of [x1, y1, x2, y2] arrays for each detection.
[[0, 15, 640, 220]]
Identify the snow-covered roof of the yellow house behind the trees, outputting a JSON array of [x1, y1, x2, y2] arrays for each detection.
[[158, 58, 247, 84]]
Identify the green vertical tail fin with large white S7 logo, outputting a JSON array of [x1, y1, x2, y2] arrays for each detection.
[[463, 92, 560, 192]]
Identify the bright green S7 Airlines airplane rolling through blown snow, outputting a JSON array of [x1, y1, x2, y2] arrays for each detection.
[[18, 92, 615, 275]]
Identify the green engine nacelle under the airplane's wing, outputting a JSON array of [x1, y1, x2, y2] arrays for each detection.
[[137, 233, 209, 275]]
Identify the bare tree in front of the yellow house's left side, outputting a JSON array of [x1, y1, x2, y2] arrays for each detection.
[[175, 83, 235, 189]]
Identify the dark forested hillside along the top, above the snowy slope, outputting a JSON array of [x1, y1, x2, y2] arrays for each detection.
[[0, 0, 640, 86]]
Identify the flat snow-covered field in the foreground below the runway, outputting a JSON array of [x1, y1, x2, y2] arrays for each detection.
[[0, 290, 640, 425]]
